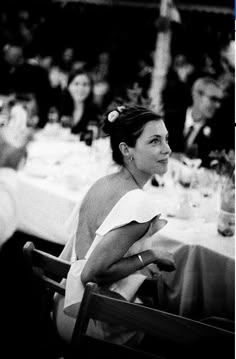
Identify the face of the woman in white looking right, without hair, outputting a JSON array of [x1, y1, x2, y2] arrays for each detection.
[[130, 120, 171, 176]]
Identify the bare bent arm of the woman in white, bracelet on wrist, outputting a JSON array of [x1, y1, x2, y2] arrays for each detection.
[[81, 222, 173, 285]]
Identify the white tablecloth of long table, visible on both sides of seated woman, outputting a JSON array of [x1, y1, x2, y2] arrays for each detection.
[[19, 134, 235, 319]]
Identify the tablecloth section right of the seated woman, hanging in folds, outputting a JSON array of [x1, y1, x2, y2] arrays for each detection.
[[147, 184, 235, 320]]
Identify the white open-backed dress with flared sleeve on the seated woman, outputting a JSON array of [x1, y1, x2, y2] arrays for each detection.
[[56, 189, 167, 344]]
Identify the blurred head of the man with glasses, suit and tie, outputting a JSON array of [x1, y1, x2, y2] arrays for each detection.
[[192, 77, 224, 121]]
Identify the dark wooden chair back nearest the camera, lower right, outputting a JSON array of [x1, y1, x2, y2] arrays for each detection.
[[72, 283, 234, 359]]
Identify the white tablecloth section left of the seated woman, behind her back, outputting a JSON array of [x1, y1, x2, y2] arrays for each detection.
[[19, 132, 115, 244]]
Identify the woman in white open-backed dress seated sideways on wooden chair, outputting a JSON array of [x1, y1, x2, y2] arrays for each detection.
[[55, 107, 175, 344]]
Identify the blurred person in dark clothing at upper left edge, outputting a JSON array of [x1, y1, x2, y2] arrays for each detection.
[[0, 42, 50, 128]]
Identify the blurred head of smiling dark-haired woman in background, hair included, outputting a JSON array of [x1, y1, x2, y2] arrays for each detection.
[[67, 69, 93, 105]]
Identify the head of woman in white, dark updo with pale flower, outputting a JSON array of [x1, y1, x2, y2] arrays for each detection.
[[103, 106, 171, 180]]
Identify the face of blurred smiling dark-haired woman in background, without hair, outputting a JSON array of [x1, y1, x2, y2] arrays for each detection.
[[68, 74, 91, 102]]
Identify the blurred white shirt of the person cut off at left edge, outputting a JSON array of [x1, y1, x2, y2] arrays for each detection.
[[0, 168, 19, 245]]
